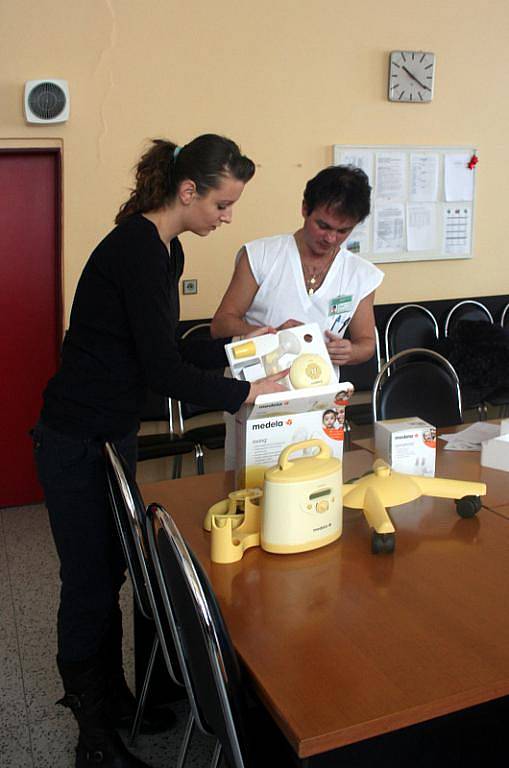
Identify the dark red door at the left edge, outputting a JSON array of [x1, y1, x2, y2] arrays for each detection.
[[0, 150, 62, 507]]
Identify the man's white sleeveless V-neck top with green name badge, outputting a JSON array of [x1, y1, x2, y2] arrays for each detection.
[[244, 235, 384, 336]]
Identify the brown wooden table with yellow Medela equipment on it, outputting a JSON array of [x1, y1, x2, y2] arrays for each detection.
[[142, 450, 509, 765]]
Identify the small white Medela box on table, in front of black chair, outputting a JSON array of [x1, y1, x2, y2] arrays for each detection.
[[375, 417, 437, 477]]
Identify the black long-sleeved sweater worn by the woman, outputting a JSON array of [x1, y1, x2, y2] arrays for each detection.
[[41, 215, 249, 439]]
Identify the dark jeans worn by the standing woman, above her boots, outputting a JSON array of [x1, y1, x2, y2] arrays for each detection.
[[33, 422, 136, 664]]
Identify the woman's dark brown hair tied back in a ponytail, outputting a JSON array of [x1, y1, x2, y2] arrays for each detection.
[[115, 133, 255, 224]]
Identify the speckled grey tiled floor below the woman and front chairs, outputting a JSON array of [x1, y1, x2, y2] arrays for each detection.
[[0, 452, 221, 768]]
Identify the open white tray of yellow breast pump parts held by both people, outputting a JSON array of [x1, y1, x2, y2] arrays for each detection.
[[225, 323, 336, 390]]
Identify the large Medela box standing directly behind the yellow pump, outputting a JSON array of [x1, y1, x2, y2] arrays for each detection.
[[235, 382, 353, 488]]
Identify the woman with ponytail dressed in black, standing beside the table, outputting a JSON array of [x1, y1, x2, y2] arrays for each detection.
[[33, 134, 285, 768]]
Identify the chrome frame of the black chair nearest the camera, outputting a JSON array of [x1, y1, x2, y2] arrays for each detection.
[[147, 504, 246, 768]]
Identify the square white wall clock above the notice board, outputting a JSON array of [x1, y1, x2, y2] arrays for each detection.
[[389, 51, 435, 104]]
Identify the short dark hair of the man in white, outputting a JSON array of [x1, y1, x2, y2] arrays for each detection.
[[304, 165, 371, 222]]
